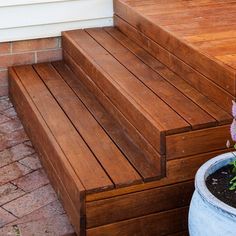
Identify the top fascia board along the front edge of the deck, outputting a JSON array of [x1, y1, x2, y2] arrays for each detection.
[[114, 0, 235, 99]]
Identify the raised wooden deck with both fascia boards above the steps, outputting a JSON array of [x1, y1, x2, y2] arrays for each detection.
[[114, 0, 236, 112]]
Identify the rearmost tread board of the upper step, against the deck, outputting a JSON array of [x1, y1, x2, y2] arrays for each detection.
[[105, 27, 232, 124]]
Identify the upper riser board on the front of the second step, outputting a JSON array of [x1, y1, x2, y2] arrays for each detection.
[[62, 33, 165, 155]]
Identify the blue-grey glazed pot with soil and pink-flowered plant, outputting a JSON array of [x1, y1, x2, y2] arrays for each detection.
[[189, 102, 236, 236]]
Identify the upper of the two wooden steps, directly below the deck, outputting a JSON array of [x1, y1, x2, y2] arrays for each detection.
[[63, 28, 232, 159]]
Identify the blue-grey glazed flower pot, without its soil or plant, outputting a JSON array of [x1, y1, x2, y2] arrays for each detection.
[[189, 153, 236, 236]]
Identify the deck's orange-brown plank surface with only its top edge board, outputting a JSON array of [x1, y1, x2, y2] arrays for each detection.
[[114, 0, 236, 95]]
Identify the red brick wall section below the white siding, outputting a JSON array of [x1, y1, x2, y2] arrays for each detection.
[[0, 37, 62, 96]]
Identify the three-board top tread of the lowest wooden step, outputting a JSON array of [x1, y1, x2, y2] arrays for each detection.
[[11, 62, 161, 192]]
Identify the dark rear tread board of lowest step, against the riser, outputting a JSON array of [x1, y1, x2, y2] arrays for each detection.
[[53, 62, 162, 182]]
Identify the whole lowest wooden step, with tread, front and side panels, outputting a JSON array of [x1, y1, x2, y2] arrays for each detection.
[[9, 62, 200, 235]]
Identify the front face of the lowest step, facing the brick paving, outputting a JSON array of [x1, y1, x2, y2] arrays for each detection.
[[9, 69, 85, 235]]
